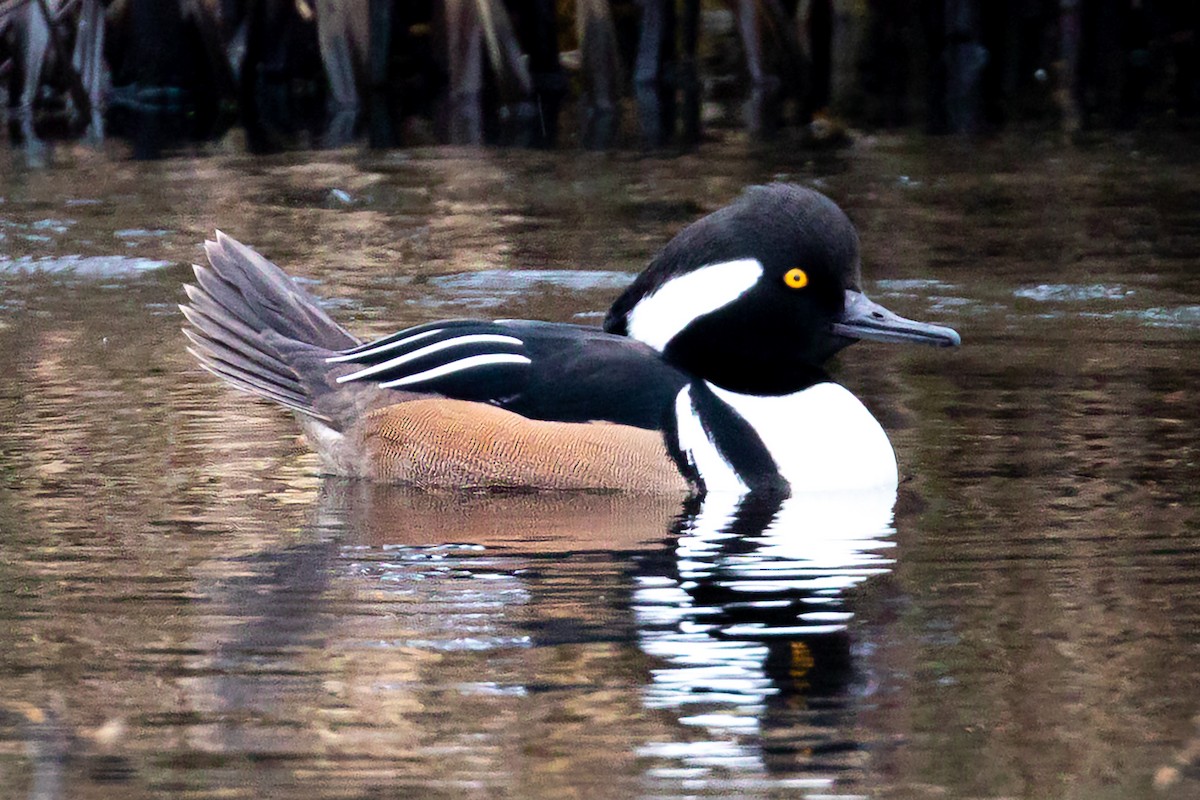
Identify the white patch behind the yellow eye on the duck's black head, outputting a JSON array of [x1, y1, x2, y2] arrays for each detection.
[[628, 258, 762, 353]]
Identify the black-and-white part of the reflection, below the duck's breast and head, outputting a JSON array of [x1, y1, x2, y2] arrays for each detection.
[[632, 487, 896, 788]]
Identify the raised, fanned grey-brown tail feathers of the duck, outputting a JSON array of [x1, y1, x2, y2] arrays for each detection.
[[180, 230, 360, 421]]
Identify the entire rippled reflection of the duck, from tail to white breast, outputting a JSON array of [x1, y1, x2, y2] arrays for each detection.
[[166, 481, 895, 796]]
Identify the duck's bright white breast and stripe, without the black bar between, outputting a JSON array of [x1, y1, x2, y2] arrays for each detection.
[[676, 383, 898, 494]]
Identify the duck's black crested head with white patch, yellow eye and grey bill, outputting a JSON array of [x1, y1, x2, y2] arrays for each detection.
[[605, 184, 959, 395]]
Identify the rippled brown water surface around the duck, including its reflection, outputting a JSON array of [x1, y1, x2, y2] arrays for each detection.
[[0, 138, 1200, 799]]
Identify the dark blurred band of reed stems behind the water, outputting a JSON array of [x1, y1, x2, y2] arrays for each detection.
[[0, 0, 1200, 154]]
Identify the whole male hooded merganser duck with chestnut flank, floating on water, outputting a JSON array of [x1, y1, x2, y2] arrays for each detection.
[[180, 184, 961, 497]]
